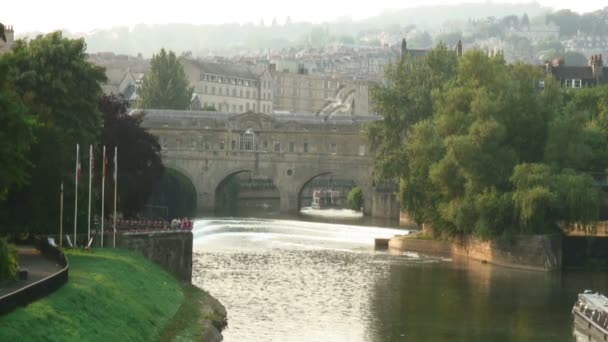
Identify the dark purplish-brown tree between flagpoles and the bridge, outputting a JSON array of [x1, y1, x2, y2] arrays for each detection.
[[99, 95, 164, 217]]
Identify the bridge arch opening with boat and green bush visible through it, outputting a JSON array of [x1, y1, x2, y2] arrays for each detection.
[[298, 172, 365, 217]]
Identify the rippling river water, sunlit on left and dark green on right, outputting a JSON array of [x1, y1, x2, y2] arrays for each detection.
[[193, 214, 608, 342]]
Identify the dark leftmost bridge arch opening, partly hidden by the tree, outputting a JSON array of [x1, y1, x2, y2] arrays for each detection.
[[144, 168, 196, 220]]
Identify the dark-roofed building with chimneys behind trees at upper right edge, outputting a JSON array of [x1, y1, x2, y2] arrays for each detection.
[[545, 55, 608, 88]]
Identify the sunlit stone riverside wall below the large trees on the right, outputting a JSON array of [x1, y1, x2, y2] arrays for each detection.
[[389, 235, 562, 271]]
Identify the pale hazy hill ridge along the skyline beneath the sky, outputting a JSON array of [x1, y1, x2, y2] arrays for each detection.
[[10, 3, 550, 57]]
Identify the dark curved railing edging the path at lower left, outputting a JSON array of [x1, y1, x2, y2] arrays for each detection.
[[0, 240, 69, 315]]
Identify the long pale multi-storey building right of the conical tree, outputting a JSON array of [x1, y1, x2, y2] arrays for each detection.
[[180, 57, 273, 114]]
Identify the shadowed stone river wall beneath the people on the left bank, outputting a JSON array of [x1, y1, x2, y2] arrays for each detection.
[[111, 232, 192, 283]]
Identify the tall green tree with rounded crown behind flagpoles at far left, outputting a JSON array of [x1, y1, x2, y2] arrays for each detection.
[[0, 32, 105, 231]]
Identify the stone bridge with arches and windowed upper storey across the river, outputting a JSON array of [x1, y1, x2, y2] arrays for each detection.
[[143, 110, 398, 217]]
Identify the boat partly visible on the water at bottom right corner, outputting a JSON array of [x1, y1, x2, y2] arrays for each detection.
[[572, 290, 608, 341]]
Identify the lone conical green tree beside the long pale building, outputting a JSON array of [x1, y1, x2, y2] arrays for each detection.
[[138, 49, 194, 109]]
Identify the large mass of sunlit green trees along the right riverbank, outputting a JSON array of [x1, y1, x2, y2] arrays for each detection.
[[368, 47, 608, 238]]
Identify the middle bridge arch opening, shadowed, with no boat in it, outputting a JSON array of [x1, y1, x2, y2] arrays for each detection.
[[215, 170, 281, 216]]
